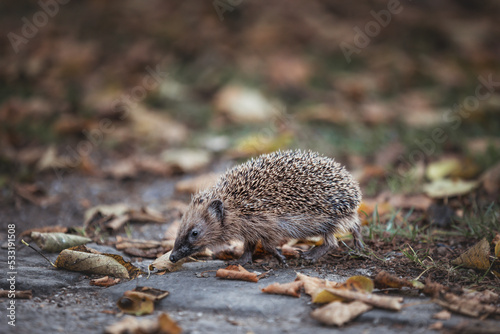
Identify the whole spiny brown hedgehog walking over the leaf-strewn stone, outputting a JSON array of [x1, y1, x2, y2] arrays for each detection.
[[170, 150, 363, 265]]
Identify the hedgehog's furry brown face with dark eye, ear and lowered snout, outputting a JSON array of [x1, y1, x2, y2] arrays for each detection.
[[170, 195, 224, 262]]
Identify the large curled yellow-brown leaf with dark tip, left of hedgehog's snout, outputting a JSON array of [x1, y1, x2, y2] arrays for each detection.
[[55, 246, 142, 278]]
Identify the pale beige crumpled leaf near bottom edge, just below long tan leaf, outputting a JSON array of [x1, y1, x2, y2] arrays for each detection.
[[311, 301, 373, 326]]
